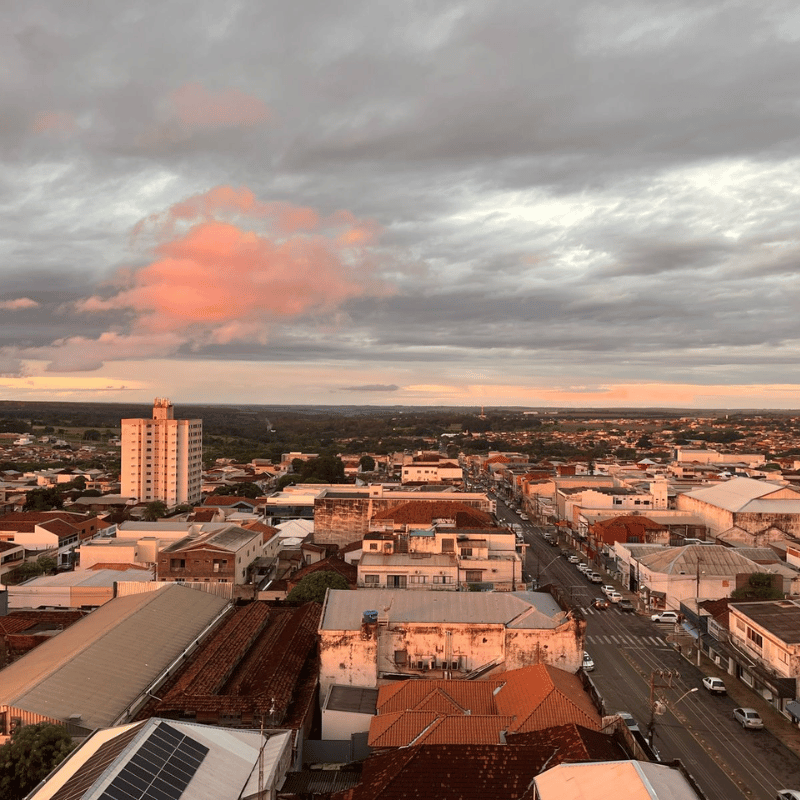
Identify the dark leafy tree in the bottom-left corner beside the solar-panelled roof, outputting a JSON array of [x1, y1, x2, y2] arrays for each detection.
[[0, 722, 73, 800]]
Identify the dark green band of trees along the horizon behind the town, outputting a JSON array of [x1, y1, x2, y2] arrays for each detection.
[[0, 401, 795, 463]]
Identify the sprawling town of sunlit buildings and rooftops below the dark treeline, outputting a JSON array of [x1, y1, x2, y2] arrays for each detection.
[[0, 406, 800, 800]]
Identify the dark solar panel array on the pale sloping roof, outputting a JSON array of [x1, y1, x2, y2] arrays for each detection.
[[100, 723, 208, 800]]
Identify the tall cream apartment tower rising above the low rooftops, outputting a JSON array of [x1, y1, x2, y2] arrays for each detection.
[[120, 397, 203, 507]]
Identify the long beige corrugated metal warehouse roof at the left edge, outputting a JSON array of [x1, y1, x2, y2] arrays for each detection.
[[0, 584, 228, 728]]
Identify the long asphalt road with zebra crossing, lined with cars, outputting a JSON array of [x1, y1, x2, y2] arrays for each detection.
[[490, 500, 800, 800]]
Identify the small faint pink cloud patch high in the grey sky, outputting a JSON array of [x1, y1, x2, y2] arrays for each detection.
[[169, 83, 269, 128]]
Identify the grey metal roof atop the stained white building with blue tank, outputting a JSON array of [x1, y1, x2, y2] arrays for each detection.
[[320, 589, 565, 631]]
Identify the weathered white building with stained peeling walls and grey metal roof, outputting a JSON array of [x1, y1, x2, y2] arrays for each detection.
[[319, 589, 586, 697]]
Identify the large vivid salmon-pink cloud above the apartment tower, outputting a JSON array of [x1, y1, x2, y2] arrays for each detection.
[[78, 186, 394, 342]]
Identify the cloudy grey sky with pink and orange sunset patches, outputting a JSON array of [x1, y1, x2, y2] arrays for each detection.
[[0, 0, 800, 408]]
